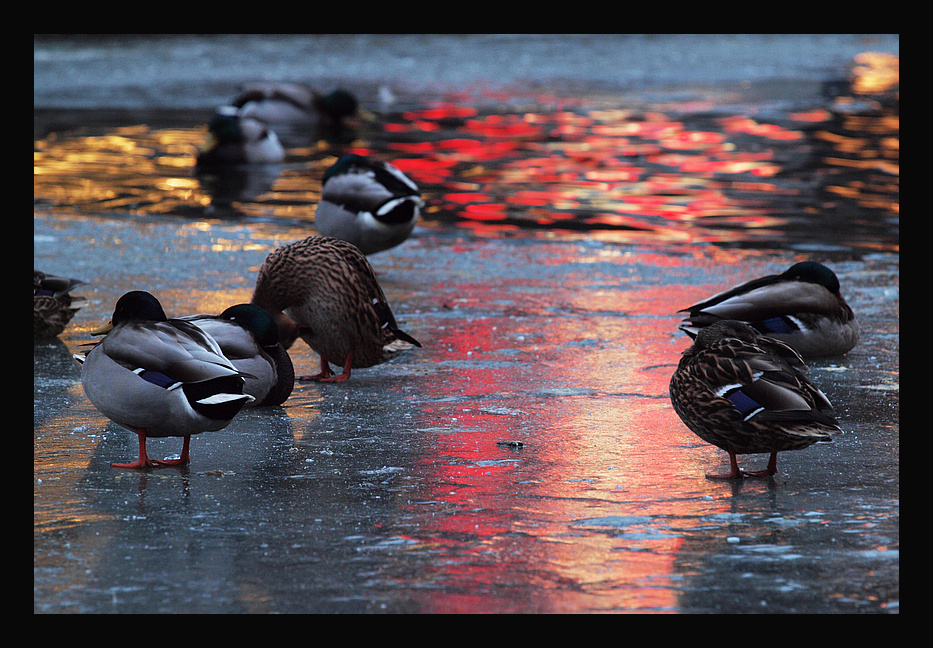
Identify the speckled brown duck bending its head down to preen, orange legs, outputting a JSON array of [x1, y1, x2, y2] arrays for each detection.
[[252, 236, 421, 382]]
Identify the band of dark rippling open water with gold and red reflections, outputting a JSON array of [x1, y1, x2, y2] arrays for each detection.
[[34, 49, 900, 251]]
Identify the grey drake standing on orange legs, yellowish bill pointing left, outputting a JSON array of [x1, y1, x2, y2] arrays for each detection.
[[75, 290, 253, 468]]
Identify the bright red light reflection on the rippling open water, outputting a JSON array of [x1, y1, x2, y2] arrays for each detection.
[[387, 105, 802, 247]]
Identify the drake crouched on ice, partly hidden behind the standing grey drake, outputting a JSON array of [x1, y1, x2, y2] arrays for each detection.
[[179, 304, 295, 406]]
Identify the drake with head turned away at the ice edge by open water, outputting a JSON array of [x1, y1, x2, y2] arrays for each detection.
[[314, 154, 424, 254]]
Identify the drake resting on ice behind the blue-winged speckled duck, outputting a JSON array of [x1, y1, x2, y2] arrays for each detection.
[[679, 261, 858, 357]]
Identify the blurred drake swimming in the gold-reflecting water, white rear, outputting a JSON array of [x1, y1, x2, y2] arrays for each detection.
[[197, 106, 285, 168]]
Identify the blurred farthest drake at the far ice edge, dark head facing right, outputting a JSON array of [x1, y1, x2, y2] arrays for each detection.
[[231, 83, 361, 128]]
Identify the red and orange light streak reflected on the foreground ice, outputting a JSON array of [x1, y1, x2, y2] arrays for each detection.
[[396, 245, 740, 612]]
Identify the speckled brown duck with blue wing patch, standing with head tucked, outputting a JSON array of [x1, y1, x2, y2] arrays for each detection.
[[670, 320, 840, 479]]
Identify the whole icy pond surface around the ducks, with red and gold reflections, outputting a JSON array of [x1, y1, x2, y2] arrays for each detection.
[[34, 37, 899, 613]]
